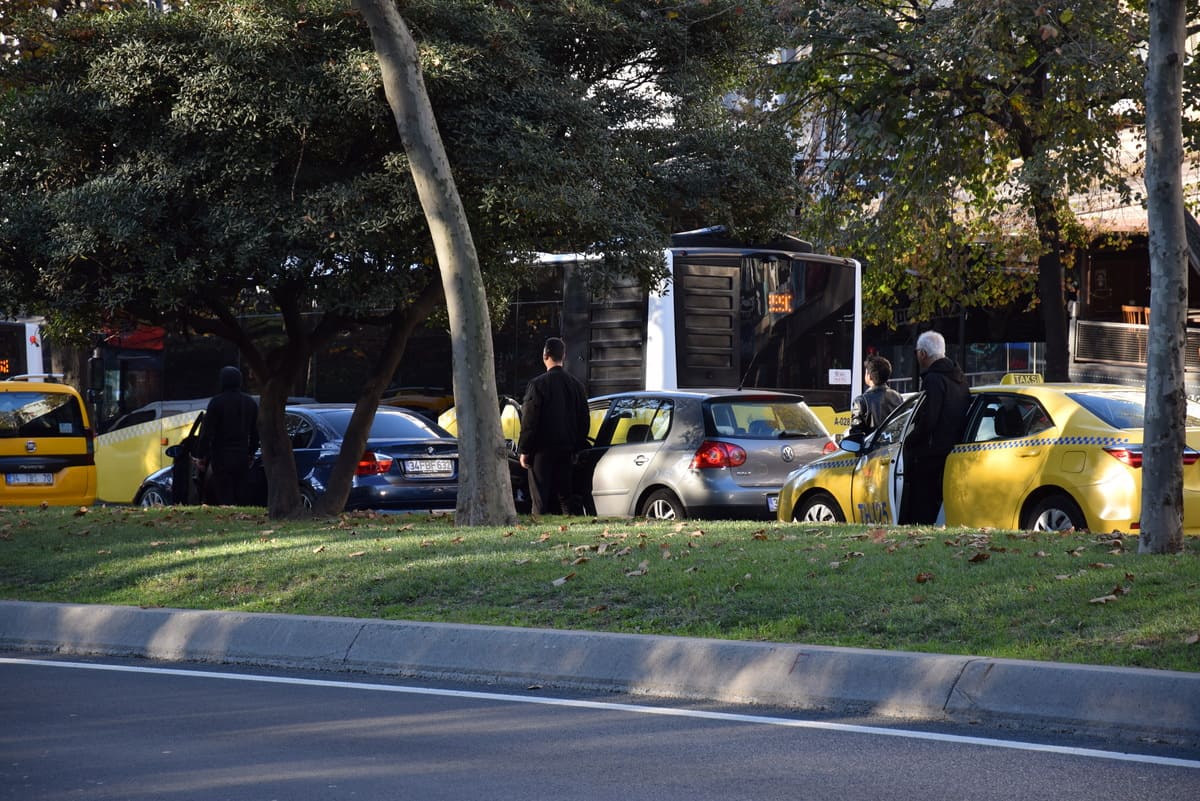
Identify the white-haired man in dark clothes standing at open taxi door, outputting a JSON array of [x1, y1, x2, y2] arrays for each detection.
[[900, 331, 971, 524]]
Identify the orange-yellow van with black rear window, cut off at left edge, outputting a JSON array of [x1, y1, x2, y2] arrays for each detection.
[[0, 375, 96, 506]]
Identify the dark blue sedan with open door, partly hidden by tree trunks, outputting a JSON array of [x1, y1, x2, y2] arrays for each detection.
[[133, 404, 458, 510]]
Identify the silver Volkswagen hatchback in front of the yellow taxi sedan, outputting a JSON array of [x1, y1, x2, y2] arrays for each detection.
[[575, 390, 833, 520]]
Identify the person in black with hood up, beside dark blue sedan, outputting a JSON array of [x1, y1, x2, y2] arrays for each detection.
[[199, 366, 258, 506]]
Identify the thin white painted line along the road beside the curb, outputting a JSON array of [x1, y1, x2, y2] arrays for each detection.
[[0, 657, 1200, 770]]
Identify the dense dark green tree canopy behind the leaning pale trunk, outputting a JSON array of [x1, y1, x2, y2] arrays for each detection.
[[0, 0, 791, 514]]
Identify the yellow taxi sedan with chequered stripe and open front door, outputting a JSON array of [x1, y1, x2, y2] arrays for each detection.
[[779, 377, 1200, 535]]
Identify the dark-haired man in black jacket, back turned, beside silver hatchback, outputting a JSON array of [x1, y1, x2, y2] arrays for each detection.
[[517, 337, 588, 514]]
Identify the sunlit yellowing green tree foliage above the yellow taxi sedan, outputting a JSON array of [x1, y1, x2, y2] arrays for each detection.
[[781, 0, 1161, 330]]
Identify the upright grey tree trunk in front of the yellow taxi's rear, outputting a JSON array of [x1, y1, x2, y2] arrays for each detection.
[[1138, 0, 1188, 554]]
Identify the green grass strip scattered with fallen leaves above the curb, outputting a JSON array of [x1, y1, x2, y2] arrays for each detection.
[[0, 506, 1200, 671]]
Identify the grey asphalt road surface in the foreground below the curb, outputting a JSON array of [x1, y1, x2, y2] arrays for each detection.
[[7, 656, 1200, 801]]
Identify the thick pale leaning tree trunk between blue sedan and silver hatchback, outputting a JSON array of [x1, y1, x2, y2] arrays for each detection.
[[354, 0, 517, 525]]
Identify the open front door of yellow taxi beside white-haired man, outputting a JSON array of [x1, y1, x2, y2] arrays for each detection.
[[851, 396, 920, 525]]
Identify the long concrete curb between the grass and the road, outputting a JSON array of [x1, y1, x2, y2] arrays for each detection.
[[0, 601, 1200, 746]]
